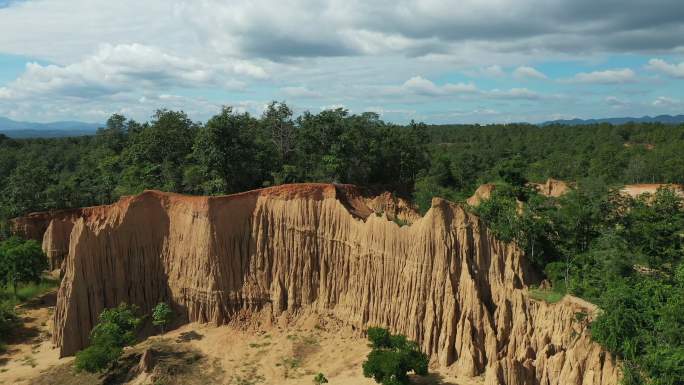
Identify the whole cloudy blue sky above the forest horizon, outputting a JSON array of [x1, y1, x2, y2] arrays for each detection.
[[0, 0, 684, 123]]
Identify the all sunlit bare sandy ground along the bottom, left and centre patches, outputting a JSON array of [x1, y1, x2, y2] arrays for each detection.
[[0, 294, 482, 385]]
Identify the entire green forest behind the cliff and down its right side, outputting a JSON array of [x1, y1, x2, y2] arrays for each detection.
[[0, 102, 684, 385]]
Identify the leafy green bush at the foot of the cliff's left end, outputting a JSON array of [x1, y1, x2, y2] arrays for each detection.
[[75, 303, 141, 373]]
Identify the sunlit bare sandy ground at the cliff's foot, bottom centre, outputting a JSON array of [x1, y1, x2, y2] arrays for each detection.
[[144, 323, 482, 385]]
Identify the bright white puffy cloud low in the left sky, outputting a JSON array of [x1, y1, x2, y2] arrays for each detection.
[[2, 44, 266, 98]]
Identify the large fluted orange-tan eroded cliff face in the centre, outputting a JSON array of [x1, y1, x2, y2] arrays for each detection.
[[16, 184, 618, 385]]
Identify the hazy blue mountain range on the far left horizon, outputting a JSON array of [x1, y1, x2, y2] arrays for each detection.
[[0, 117, 103, 138]]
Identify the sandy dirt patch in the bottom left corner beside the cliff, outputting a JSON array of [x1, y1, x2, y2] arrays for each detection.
[[0, 291, 69, 385]]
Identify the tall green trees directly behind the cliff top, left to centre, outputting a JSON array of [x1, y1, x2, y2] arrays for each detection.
[[0, 102, 429, 228]]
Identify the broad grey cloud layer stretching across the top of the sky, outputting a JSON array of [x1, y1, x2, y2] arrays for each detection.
[[0, 0, 684, 61]]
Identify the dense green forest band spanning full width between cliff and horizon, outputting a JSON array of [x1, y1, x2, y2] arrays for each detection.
[[0, 102, 684, 219]]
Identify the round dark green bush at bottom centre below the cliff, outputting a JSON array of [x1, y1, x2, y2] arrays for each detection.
[[363, 328, 428, 385]]
